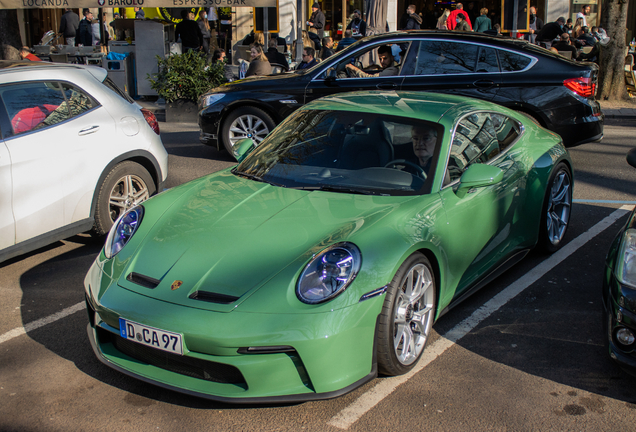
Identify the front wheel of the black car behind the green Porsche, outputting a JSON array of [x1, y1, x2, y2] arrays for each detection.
[[221, 107, 276, 154]]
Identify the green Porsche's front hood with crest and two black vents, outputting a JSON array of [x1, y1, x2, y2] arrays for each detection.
[[118, 171, 412, 312]]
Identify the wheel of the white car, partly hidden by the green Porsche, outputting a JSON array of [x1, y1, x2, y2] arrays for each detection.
[[93, 161, 156, 236]]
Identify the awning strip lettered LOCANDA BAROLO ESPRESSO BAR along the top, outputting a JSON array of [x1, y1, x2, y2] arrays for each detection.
[[0, 0, 276, 9]]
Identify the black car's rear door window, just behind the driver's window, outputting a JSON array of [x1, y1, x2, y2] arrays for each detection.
[[412, 40, 476, 75]]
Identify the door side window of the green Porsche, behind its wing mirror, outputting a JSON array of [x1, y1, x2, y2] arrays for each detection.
[[447, 113, 501, 183]]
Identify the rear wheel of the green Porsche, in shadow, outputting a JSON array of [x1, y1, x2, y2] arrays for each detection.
[[539, 162, 572, 253]]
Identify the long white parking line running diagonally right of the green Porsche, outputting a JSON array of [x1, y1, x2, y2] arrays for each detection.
[[327, 205, 634, 429]]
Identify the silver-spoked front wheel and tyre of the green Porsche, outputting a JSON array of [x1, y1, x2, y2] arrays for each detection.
[[376, 252, 437, 376]]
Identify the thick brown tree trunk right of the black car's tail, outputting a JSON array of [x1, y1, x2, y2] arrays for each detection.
[[597, 0, 629, 100]]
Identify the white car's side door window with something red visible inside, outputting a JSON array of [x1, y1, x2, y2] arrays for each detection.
[[0, 82, 71, 137]]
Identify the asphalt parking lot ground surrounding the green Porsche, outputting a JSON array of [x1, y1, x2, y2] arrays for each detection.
[[0, 119, 636, 431]]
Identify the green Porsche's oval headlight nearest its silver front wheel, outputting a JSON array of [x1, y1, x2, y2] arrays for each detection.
[[296, 243, 362, 304]]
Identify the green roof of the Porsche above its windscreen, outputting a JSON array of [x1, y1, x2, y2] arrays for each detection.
[[301, 90, 504, 122]]
